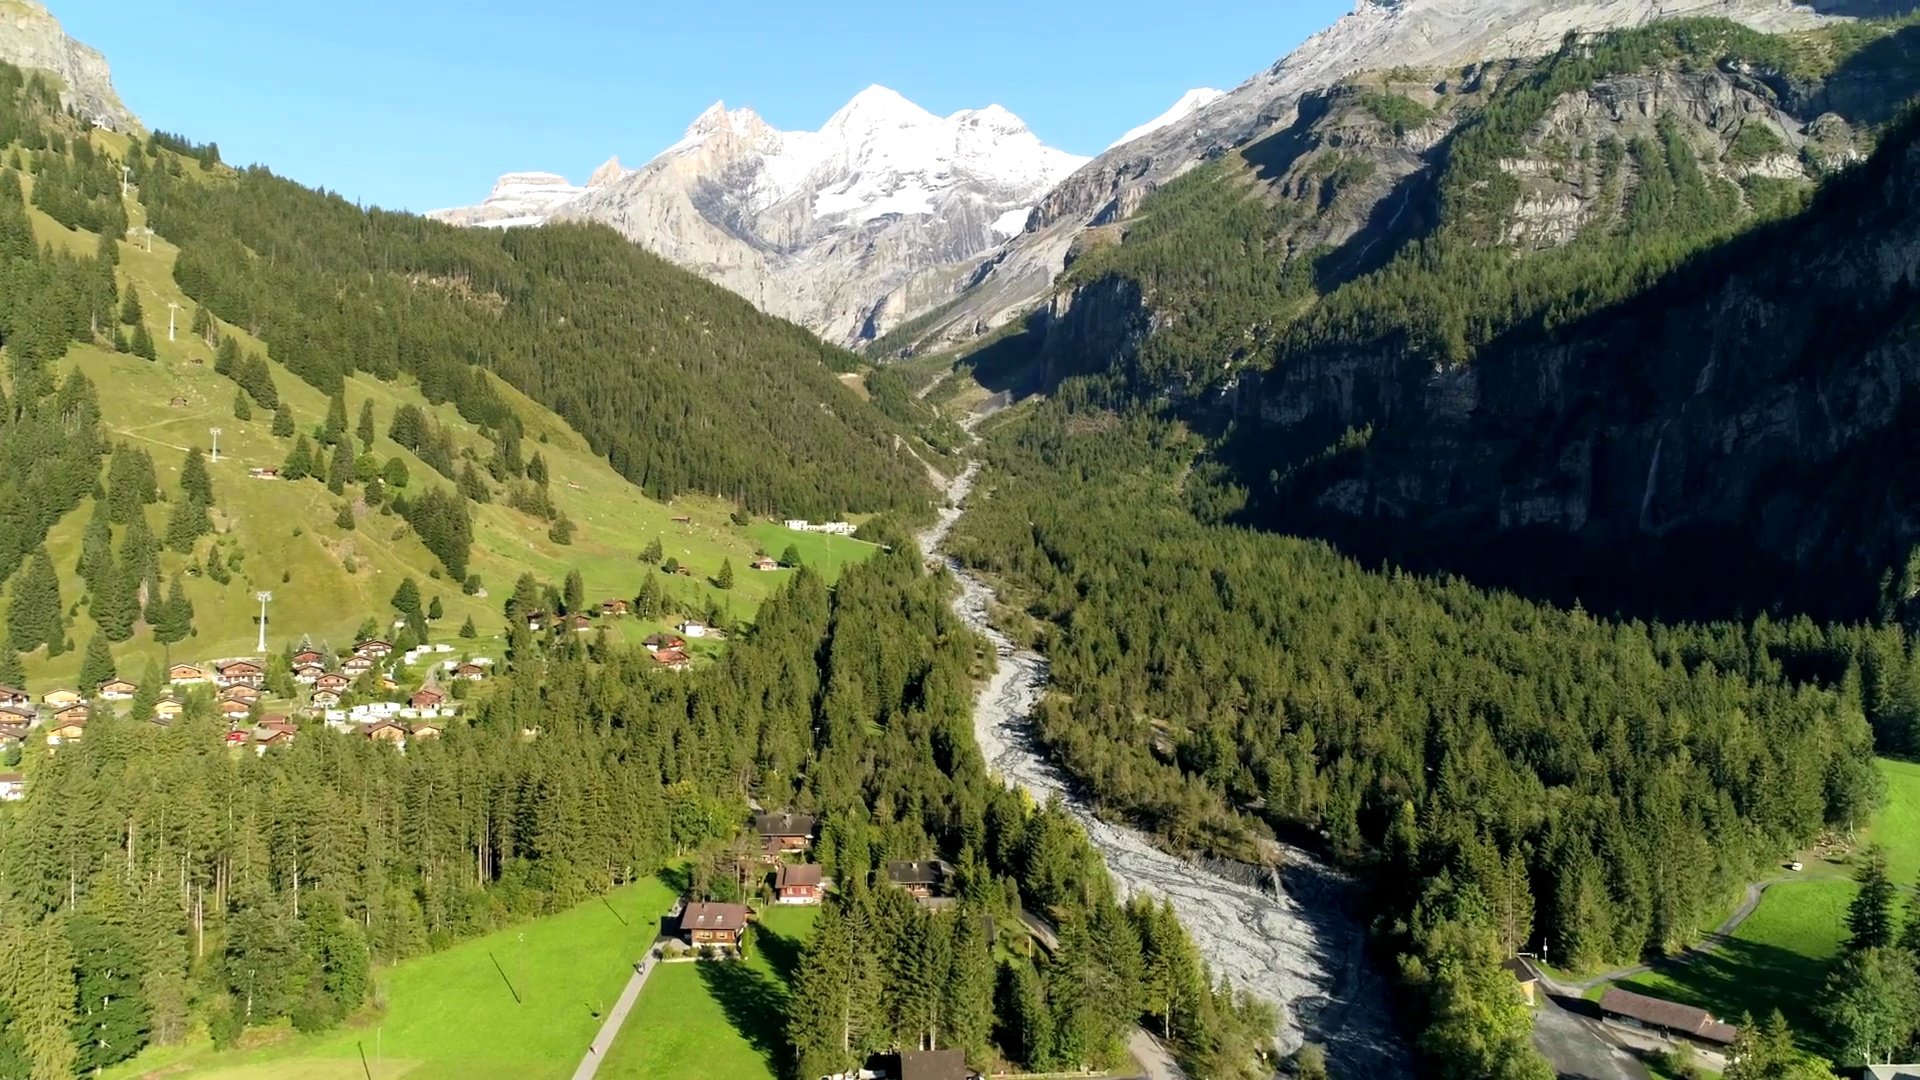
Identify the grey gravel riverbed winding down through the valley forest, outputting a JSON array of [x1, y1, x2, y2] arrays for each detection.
[[920, 465, 1411, 1076]]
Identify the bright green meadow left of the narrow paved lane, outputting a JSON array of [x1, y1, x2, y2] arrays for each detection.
[[108, 880, 683, 1080]]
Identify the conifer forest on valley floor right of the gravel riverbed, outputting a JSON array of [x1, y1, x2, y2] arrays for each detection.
[[952, 404, 1889, 1080]]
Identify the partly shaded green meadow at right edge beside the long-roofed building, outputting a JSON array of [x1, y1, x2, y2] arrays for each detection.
[[1620, 761, 1920, 1032]]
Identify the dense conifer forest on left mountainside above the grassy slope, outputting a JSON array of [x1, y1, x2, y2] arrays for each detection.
[[134, 144, 929, 519]]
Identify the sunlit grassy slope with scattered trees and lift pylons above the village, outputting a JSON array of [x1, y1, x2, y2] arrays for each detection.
[[5, 143, 870, 690]]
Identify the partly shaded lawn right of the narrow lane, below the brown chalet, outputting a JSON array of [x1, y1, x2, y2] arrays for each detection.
[[599, 907, 818, 1080]]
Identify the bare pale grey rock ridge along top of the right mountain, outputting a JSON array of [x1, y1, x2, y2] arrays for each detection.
[[906, 0, 1845, 344]]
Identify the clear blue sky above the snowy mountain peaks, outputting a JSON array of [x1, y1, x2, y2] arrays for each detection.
[[48, 0, 1352, 209]]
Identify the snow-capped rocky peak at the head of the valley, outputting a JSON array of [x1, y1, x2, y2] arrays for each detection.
[[436, 86, 1085, 344]]
